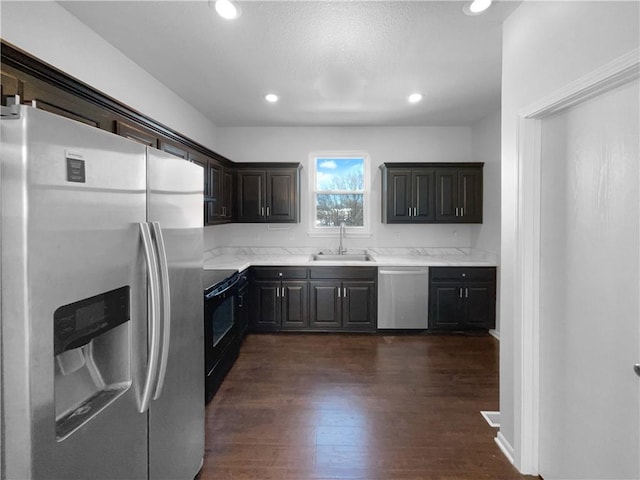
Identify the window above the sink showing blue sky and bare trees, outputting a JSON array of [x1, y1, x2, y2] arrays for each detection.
[[311, 154, 369, 233]]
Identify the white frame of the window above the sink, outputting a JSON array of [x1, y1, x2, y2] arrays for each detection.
[[308, 151, 371, 237]]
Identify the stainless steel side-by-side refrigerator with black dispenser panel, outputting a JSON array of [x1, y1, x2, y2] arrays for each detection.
[[0, 106, 204, 480]]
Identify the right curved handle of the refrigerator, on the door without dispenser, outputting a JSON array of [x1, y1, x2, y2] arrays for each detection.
[[151, 222, 171, 400]]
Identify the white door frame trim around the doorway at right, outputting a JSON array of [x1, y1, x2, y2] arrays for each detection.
[[516, 48, 640, 475]]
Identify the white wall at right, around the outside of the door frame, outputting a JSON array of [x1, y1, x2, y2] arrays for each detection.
[[500, 1, 640, 472]]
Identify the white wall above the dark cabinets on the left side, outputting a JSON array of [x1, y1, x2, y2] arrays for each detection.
[[0, 1, 215, 150]]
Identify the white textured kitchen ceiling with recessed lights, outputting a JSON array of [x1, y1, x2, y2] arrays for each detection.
[[60, 0, 520, 126]]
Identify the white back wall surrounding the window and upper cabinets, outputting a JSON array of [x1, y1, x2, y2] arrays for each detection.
[[205, 127, 480, 250]]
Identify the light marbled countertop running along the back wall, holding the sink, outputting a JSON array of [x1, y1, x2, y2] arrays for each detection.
[[204, 247, 497, 271]]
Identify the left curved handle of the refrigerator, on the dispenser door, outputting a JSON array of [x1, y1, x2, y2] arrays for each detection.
[[138, 222, 160, 413]]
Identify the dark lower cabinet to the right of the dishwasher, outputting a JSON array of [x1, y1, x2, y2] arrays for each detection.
[[429, 267, 496, 330]]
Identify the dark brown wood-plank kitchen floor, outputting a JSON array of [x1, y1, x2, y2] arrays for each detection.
[[200, 334, 533, 480]]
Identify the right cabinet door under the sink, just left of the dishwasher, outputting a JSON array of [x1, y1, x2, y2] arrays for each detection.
[[342, 282, 376, 330]]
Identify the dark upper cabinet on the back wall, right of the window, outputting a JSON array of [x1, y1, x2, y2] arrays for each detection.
[[380, 163, 483, 223]]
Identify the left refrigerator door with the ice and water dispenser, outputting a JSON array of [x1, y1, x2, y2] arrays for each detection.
[[1, 108, 149, 480]]
